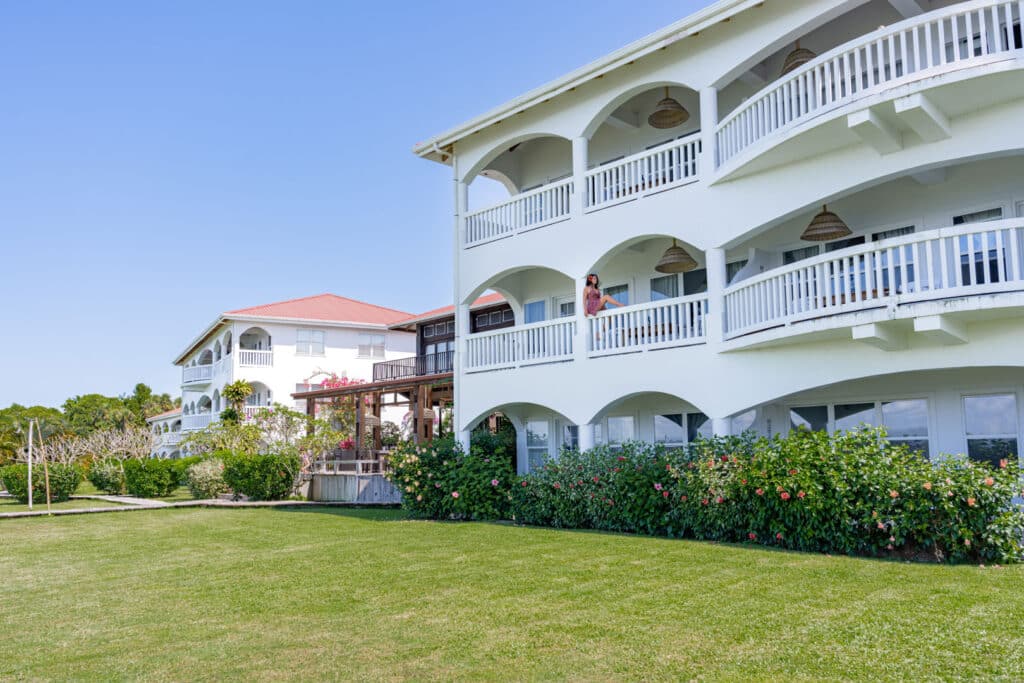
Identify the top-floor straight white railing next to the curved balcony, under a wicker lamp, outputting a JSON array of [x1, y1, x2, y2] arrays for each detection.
[[586, 135, 700, 209]]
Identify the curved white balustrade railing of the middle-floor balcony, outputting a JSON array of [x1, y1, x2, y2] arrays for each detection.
[[725, 218, 1024, 338]]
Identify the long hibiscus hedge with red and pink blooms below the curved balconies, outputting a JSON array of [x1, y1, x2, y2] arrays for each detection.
[[513, 429, 1024, 562]]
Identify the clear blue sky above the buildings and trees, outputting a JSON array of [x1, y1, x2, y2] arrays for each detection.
[[0, 0, 710, 407]]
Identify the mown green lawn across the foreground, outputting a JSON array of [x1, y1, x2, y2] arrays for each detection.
[[0, 508, 1024, 680]]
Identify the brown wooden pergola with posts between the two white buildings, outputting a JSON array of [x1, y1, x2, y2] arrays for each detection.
[[292, 373, 454, 453]]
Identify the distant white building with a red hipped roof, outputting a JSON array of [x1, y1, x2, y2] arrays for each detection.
[[174, 294, 416, 444]]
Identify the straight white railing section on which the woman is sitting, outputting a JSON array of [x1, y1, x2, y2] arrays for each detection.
[[587, 294, 708, 356]]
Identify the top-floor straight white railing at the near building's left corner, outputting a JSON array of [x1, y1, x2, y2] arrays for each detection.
[[465, 178, 572, 247]]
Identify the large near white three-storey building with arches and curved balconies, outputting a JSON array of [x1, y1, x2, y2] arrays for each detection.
[[415, 0, 1024, 472]]
